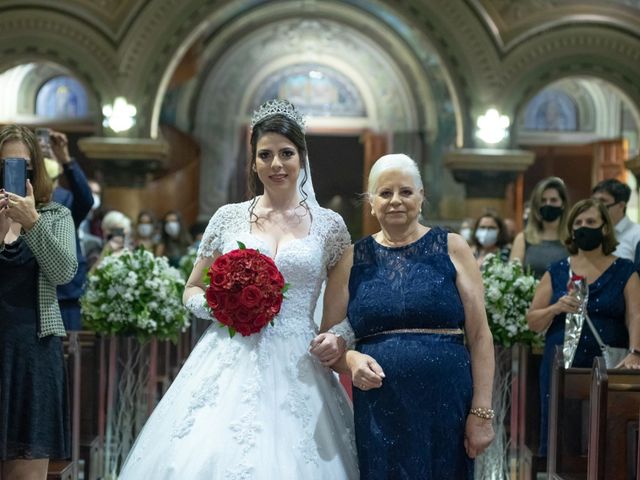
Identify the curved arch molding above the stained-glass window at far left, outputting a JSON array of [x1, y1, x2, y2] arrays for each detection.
[[0, 9, 118, 99]]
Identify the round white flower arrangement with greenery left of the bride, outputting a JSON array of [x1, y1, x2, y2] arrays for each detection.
[[81, 248, 189, 340]]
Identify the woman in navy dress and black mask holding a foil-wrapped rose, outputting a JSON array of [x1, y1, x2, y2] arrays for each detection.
[[527, 199, 640, 456]]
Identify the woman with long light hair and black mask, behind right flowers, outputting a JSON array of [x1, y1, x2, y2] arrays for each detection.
[[510, 177, 569, 278]]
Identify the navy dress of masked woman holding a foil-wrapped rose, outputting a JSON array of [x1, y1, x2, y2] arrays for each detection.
[[540, 258, 635, 456]]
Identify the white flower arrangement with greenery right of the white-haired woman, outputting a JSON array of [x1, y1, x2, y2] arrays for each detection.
[[481, 254, 543, 347]]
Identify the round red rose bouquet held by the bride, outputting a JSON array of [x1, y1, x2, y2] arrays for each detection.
[[205, 242, 289, 337]]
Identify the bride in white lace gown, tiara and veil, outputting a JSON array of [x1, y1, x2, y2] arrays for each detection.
[[119, 100, 358, 480]]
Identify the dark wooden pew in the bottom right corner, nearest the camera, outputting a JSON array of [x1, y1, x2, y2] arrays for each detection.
[[588, 357, 640, 480]]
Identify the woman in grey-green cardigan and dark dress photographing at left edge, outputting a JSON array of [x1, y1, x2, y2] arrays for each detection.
[[0, 125, 78, 480]]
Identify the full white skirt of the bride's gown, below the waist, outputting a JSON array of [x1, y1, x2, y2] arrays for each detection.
[[119, 324, 359, 480]]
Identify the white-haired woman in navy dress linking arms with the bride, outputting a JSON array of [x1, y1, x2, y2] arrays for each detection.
[[312, 155, 494, 480]]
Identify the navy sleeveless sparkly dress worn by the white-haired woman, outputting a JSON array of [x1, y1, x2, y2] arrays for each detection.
[[348, 228, 473, 480]]
